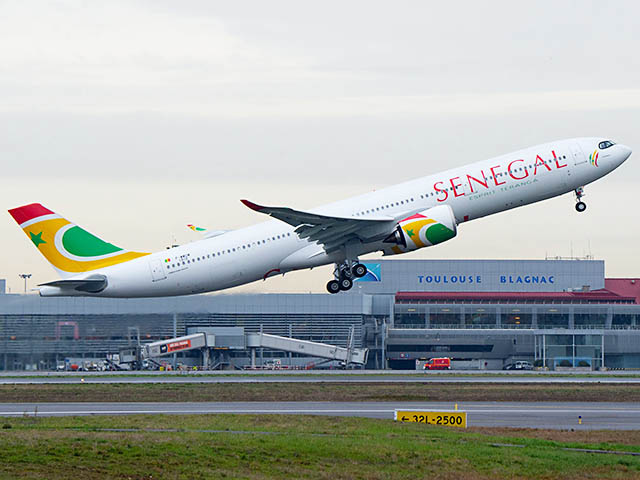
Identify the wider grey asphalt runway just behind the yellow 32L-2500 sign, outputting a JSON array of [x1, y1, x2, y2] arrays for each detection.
[[0, 402, 640, 430]]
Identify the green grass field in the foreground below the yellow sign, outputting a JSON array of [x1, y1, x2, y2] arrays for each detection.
[[0, 415, 640, 479]]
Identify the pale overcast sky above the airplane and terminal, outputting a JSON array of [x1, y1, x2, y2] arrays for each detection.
[[0, 0, 640, 292]]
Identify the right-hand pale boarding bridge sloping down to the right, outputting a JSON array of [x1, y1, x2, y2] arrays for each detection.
[[247, 333, 369, 365]]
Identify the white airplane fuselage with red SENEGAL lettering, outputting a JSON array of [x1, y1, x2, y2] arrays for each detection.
[[41, 138, 630, 297]]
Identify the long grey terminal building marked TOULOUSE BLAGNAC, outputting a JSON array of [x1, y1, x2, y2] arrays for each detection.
[[0, 260, 640, 370]]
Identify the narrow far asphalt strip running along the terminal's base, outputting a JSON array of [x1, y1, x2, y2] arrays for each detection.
[[0, 373, 640, 385]]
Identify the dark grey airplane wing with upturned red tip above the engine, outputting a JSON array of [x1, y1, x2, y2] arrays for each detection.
[[240, 200, 396, 253]]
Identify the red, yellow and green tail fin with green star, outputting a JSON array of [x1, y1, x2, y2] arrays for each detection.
[[9, 203, 148, 278]]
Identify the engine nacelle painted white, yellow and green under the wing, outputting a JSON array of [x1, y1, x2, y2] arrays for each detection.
[[384, 205, 458, 255]]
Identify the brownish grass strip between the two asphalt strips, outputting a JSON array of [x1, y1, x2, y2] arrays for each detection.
[[0, 382, 640, 403]]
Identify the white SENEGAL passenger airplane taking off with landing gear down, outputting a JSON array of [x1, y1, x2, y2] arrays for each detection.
[[9, 138, 631, 298]]
